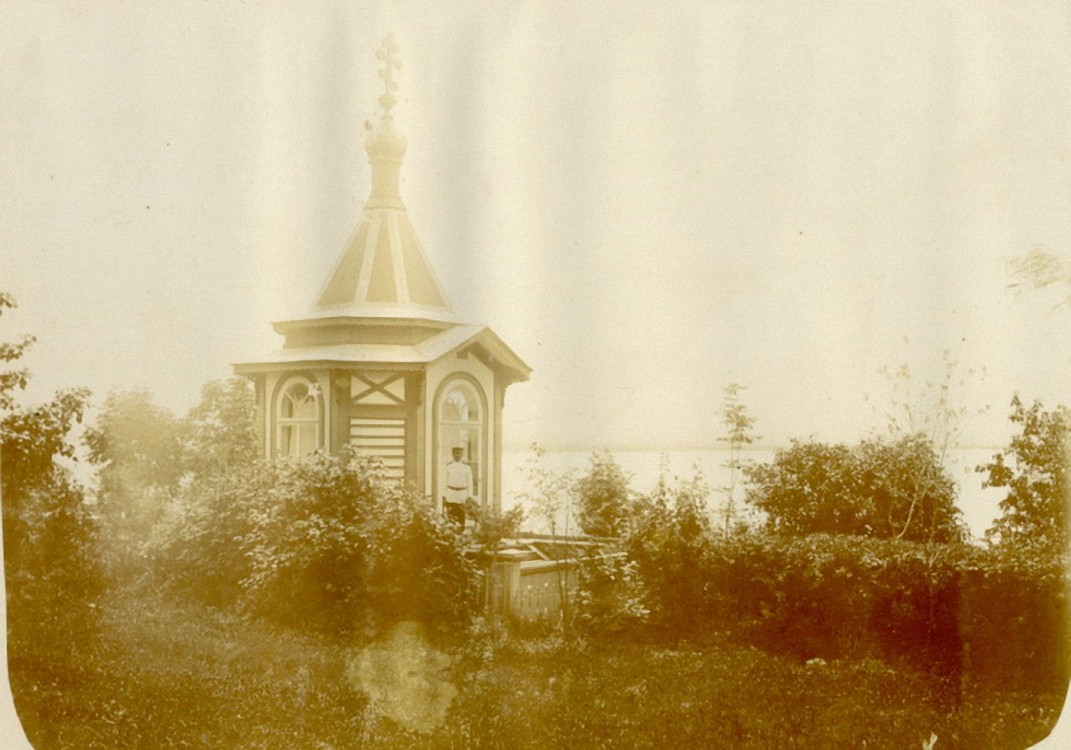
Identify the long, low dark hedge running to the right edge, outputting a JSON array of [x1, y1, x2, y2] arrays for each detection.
[[625, 525, 1071, 688]]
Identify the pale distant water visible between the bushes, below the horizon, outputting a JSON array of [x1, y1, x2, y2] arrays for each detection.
[[502, 448, 1006, 539]]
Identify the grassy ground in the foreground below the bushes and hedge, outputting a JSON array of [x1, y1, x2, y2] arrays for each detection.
[[11, 590, 1062, 750]]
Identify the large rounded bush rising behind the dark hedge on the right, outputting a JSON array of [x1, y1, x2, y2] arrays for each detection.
[[746, 435, 963, 542]]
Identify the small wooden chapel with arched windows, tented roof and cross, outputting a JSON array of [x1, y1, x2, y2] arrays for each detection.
[[235, 36, 531, 509]]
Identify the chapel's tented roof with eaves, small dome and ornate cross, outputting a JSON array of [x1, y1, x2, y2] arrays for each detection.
[[235, 36, 531, 380]]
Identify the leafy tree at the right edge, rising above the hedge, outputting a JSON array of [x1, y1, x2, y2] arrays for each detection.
[[977, 395, 1071, 550]]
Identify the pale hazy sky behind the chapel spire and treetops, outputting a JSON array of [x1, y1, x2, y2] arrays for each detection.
[[0, 0, 1071, 449]]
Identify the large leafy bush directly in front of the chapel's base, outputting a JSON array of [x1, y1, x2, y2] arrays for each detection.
[[153, 447, 476, 639]]
